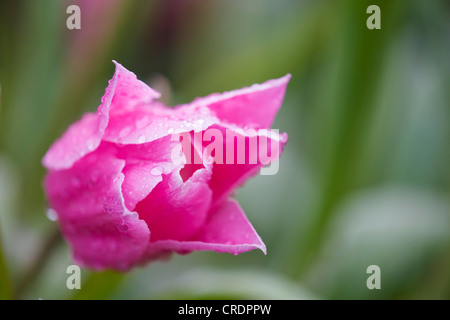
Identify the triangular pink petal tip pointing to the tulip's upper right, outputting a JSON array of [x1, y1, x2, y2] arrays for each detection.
[[191, 74, 291, 129]]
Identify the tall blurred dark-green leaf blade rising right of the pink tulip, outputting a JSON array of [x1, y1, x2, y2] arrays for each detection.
[[286, 0, 398, 276]]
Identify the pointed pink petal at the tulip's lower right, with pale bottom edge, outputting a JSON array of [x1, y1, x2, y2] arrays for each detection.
[[147, 200, 266, 257]]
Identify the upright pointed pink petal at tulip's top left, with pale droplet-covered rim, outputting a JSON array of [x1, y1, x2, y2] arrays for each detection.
[[98, 62, 219, 144]]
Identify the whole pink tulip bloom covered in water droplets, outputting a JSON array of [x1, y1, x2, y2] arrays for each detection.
[[43, 63, 290, 271]]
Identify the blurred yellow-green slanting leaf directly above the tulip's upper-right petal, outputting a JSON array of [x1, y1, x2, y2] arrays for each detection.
[[173, 3, 334, 101]]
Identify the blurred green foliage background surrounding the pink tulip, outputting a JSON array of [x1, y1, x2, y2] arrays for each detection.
[[0, 0, 450, 299]]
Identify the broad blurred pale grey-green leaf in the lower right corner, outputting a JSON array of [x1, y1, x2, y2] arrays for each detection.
[[308, 186, 450, 299]]
